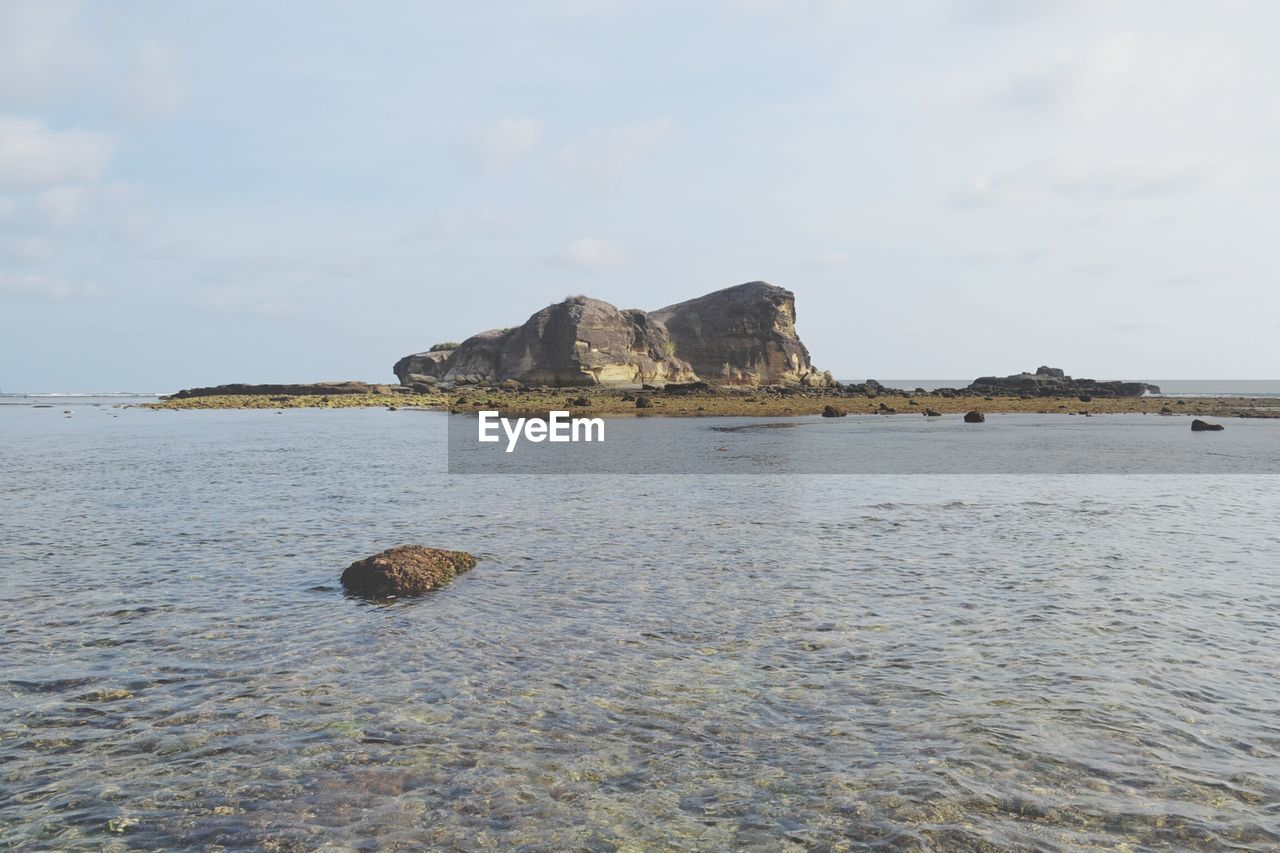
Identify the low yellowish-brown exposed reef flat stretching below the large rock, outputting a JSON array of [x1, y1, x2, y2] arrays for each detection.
[[147, 386, 1280, 418]]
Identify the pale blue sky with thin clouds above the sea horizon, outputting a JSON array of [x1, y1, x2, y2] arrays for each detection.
[[0, 0, 1280, 392]]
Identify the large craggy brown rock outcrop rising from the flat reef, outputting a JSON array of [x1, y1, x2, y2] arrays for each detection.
[[393, 282, 831, 386]]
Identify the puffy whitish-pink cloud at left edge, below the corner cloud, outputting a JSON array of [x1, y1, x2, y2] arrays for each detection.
[[0, 117, 115, 190]]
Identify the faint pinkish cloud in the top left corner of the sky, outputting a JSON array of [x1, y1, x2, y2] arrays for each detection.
[[0, 0, 86, 99]]
